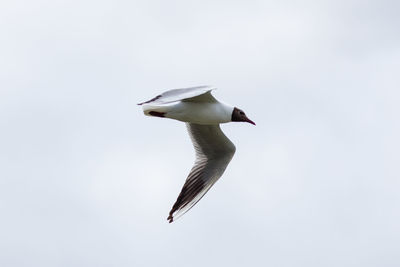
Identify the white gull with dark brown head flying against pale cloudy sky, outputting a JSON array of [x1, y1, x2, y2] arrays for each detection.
[[138, 86, 256, 223]]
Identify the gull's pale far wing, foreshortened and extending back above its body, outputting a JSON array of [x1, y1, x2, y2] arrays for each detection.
[[138, 86, 216, 105]]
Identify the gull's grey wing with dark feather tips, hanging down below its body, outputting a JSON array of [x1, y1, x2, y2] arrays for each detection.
[[168, 123, 236, 223]]
